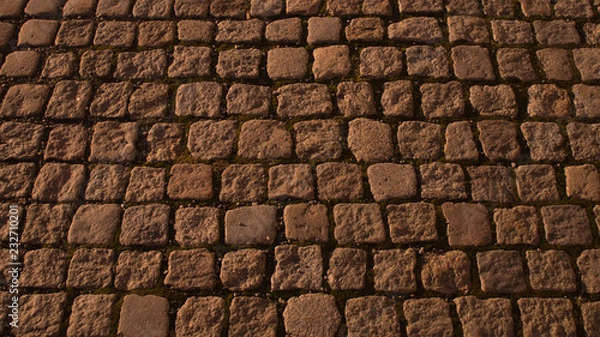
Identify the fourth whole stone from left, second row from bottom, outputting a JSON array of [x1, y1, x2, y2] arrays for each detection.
[[164, 248, 217, 291]]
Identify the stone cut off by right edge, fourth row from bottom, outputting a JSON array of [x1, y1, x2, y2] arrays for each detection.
[[565, 164, 600, 202]]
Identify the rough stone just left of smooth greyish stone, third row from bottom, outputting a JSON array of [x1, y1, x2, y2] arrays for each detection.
[[174, 207, 221, 247]]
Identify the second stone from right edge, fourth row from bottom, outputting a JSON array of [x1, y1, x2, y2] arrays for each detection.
[[515, 164, 560, 203]]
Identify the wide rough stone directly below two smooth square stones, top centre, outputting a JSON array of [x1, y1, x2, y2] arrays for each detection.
[[275, 83, 333, 117]]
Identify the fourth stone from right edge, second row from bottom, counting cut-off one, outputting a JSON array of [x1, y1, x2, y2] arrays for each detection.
[[421, 250, 471, 294]]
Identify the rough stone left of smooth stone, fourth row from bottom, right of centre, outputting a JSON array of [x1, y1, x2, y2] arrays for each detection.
[[316, 162, 363, 200]]
